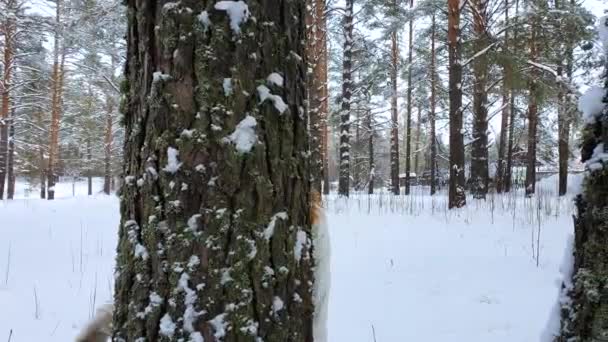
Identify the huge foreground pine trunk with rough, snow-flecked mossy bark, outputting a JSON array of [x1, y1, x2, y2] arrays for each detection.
[[113, 0, 318, 342]]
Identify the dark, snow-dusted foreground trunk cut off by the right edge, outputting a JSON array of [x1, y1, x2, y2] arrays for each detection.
[[556, 32, 608, 342]]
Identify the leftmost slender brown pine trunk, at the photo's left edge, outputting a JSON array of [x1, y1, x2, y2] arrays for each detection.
[[0, 15, 15, 199]]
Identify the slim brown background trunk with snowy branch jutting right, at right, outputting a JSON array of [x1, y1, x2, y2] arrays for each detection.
[[526, 12, 539, 196]]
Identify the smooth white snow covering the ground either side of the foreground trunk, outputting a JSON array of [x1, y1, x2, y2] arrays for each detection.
[[0, 179, 573, 342]]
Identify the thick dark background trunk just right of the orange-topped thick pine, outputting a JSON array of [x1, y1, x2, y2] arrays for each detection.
[[470, 0, 490, 199]]
